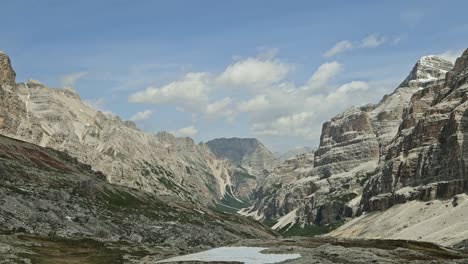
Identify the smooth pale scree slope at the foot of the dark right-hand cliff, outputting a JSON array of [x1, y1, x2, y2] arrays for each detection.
[[329, 194, 468, 246]]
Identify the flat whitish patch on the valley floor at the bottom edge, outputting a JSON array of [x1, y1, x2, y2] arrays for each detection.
[[157, 247, 301, 264]]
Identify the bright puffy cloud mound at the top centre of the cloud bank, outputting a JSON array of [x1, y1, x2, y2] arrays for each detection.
[[218, 58, 291, 88]]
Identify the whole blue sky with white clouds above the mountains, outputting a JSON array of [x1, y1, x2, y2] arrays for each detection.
[[0, 0, 468, 152]]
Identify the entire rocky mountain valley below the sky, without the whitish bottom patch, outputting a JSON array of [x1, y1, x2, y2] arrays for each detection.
[[0, 50, 468, 263]]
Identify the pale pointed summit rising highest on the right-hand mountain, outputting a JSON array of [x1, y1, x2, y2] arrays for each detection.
[[399, 55, 453, 87]]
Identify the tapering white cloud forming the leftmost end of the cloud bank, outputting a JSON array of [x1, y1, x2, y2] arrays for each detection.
[[129, 72, 210, 110]]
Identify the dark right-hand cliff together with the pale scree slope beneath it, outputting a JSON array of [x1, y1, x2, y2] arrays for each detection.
[[328, 50, 468, 247]]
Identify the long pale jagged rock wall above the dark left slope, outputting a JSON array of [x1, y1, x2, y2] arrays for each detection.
[[0, 54, 236, 204]]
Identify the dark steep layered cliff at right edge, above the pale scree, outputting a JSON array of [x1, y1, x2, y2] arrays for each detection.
[[361, 51, 468, 211]]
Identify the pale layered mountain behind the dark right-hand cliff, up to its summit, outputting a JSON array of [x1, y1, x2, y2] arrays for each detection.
[[247, 56, 456, 229]]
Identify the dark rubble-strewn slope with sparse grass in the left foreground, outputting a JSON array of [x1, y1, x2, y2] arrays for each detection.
[[0, 136, 274, 248]]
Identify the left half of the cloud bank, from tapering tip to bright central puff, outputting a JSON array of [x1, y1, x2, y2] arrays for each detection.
[[128, 52, 292, 117]]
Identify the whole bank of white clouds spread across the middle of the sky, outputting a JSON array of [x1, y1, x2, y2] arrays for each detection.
[[129, 49, 393, 146]]
